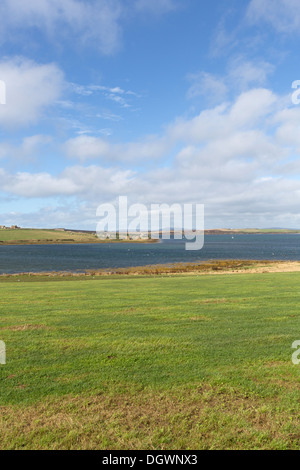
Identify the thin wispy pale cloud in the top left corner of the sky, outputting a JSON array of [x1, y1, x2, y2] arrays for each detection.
[[0, 0, 122, 54]]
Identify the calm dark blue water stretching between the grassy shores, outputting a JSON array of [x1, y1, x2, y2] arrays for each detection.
[[0, 234, 300, 274]]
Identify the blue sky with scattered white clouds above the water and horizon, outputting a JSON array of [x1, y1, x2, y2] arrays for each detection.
[[0, 0, 300, 230]]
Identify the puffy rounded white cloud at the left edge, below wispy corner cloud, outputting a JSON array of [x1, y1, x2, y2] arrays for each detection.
[[0, 58, 64, 127]]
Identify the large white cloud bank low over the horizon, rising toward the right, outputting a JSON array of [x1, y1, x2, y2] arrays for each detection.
[[0, 89, 300, 228]]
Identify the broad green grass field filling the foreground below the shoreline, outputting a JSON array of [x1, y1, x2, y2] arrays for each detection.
[[0, 272, 300, 450]]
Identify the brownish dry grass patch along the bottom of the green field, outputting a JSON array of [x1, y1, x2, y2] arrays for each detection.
[[0, 385, 300, 450]]
